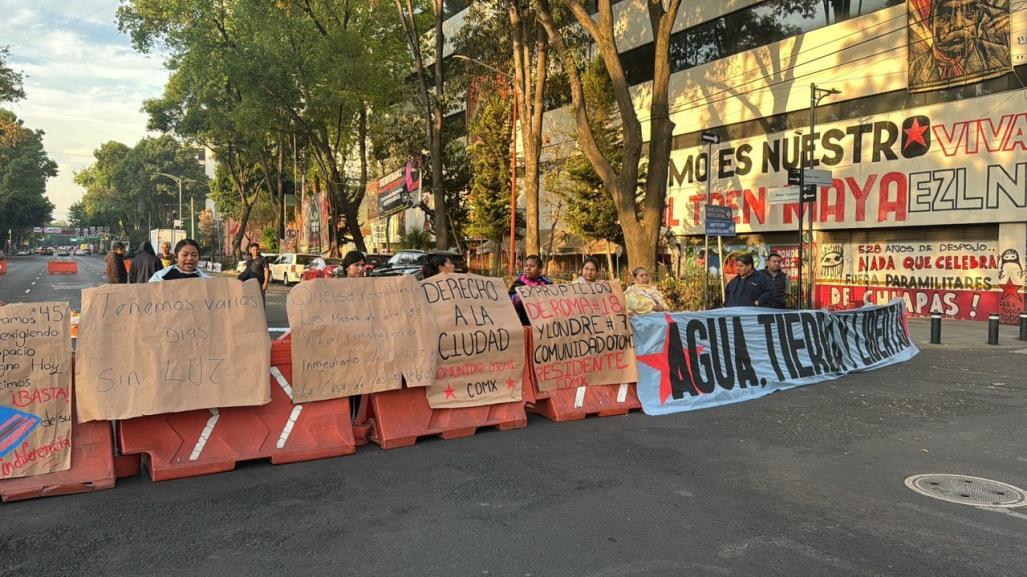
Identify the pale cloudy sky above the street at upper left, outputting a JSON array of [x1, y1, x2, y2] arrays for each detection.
[[0, 0, 167, 220]]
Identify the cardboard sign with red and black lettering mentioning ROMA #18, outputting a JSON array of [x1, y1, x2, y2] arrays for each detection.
[[517, 280, 638, 391]]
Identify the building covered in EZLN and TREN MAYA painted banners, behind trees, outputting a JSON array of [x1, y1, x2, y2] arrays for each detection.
[[445, 0, 1027, 322]]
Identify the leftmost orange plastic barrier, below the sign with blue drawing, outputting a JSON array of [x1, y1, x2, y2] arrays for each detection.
[[0, 414, 115, 501]]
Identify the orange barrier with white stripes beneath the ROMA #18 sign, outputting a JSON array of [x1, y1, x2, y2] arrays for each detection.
[[522, 328, 642, 422]]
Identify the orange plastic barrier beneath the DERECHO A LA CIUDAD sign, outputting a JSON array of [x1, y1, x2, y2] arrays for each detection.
[[367, 388, 528, 449]]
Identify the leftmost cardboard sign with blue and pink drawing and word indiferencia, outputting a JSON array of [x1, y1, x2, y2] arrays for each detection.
[[0, 303, 72, 478]]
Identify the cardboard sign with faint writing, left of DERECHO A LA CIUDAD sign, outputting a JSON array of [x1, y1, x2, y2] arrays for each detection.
[[286, 275, 439, 402]]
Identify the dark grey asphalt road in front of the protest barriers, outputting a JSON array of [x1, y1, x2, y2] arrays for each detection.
[[0, 258, 1027, 577]]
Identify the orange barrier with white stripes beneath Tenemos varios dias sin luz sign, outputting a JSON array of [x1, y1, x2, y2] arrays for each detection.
[[118, 341, 356, 480]]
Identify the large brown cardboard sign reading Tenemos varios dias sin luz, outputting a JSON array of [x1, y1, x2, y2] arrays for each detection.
[[75, 278, 271, 423]]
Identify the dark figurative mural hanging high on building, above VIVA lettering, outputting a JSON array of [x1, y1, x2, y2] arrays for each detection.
[[907, 0, 1013, 92]]
